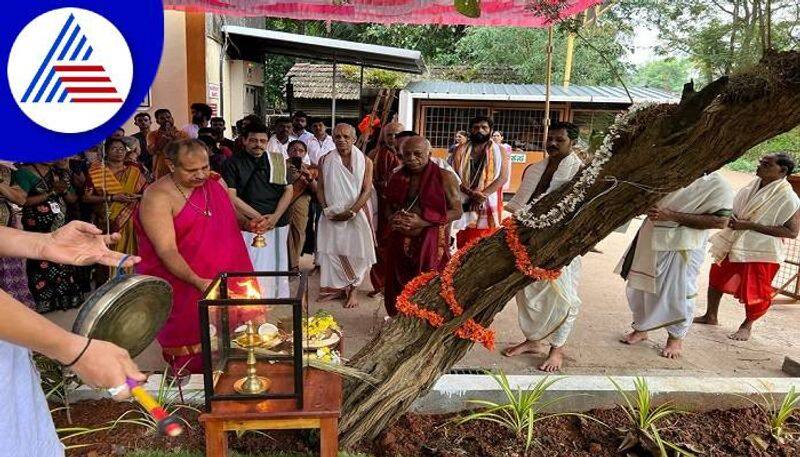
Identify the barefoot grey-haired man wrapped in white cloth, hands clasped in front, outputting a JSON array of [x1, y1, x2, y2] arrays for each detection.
[[317, 124, 375, 308]]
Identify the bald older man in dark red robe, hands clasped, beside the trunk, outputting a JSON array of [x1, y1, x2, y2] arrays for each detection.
[[384, 136, 461, 316]]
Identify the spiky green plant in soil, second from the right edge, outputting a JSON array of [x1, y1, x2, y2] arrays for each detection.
[[608, 377, 692, 457]]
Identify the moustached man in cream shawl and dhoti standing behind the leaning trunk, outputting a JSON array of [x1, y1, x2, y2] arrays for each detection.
[[503, 123, 583, 372]]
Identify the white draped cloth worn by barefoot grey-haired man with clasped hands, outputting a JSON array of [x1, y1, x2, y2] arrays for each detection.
[[317, 147, 375, 289]]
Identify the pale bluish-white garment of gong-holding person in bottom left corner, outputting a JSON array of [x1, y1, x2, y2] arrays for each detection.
[[0, 341, 64, 457]]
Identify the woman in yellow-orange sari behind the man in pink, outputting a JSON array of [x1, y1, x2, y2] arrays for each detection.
[[83, 138, 147, 273]]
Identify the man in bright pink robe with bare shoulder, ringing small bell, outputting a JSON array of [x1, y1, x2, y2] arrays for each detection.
[[135, 140, 266, 373]]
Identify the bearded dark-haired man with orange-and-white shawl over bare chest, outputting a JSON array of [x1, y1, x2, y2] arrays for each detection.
[[453, 116, 509, 248]]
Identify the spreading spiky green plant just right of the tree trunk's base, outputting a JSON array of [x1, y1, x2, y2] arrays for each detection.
[[455, 370, 594, 451]]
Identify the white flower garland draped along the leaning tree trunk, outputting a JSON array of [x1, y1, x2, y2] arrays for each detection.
[[514, 102, 657, 228]]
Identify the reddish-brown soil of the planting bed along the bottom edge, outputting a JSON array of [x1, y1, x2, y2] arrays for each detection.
[[53, 400, 800, 457]]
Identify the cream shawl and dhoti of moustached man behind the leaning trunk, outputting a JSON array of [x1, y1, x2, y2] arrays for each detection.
[[506, 154, 582, 347]]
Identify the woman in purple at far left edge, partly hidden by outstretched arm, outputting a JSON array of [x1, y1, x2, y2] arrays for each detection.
[[0, 163, 34, 308]]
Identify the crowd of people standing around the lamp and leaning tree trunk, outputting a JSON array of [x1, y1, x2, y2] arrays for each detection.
[[0, 104, 800, 378]]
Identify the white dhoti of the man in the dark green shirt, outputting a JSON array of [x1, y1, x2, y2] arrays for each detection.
[[247, 225, 289, 298]]
